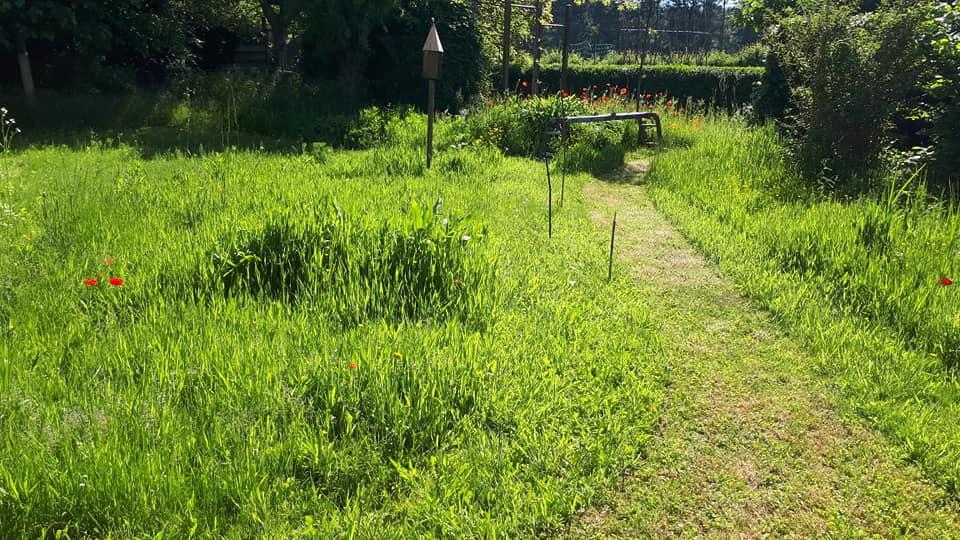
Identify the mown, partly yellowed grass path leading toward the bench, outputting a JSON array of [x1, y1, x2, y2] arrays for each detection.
[[567, 162, 960, 538]]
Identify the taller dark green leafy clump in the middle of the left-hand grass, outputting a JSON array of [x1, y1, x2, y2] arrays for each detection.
[[205, 200, 493, 324]]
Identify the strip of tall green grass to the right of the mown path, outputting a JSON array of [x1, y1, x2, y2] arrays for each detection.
[[648, 114, 960, 492]]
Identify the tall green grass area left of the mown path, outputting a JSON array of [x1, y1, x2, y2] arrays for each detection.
[[0, 115, 662, 538]]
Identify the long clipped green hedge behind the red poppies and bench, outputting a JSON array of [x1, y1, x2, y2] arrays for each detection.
[[510, 64, 763, 107]]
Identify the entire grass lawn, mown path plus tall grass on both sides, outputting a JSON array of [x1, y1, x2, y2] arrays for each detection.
[[0, 102, 960, 538]]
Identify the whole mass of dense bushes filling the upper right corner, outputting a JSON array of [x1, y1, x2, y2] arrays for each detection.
[[754, 0, 960, 189]]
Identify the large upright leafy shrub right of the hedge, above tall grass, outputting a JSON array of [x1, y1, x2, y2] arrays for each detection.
[[768, 2, 918, 181]]
